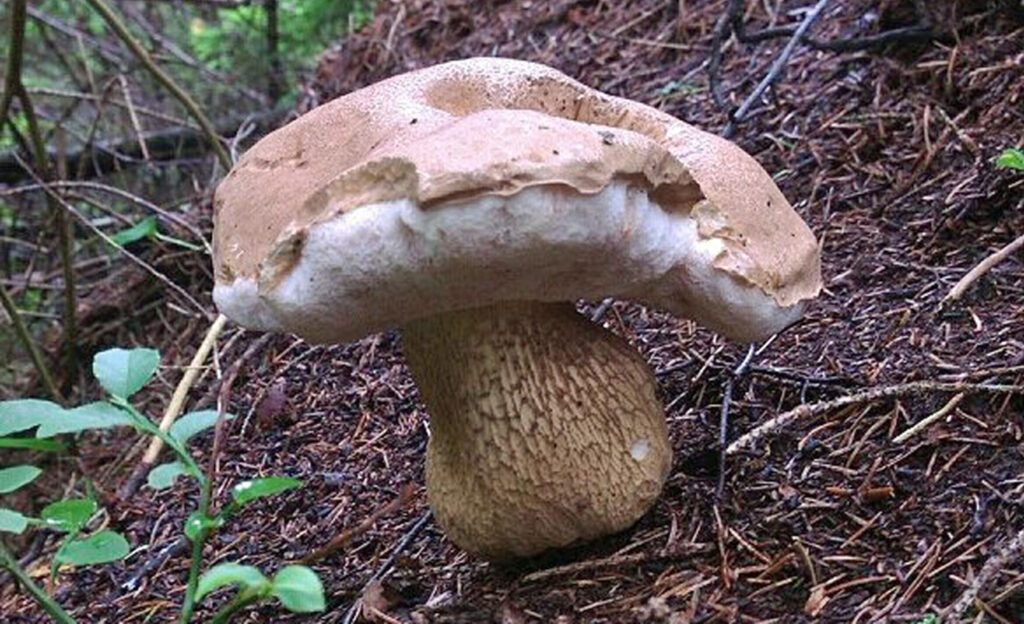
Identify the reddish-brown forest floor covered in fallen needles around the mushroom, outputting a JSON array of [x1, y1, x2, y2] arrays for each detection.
[[0, 0, 1024, 624]]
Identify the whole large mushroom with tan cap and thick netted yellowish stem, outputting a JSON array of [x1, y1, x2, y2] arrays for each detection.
[[214, 58, 820, 560]]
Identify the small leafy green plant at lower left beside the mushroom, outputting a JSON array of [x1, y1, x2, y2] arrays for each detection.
[[0, 348, 326, 624]]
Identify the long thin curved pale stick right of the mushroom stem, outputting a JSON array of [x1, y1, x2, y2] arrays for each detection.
[[725, 381, 1024, 455]]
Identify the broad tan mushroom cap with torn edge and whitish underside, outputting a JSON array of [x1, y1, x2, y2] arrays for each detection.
[[214, 57, 820, 342]]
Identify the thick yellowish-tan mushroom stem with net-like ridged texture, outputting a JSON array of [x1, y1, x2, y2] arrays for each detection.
[[402, 302, 672, 560]]
